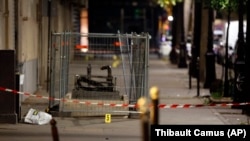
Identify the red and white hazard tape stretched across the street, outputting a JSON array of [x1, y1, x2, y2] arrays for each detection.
[[0, 87, 250, 109]]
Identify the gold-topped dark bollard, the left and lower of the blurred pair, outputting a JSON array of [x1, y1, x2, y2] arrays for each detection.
[[137, 97, 149, 141]]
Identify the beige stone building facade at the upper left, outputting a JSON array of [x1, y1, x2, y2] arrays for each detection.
[[0, 0, 74, 99]]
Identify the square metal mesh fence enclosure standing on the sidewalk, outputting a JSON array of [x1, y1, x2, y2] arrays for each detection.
[[49, 32, 150, 116]]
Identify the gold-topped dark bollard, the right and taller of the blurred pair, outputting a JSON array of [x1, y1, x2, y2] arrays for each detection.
[[150, 86, 159, 125]]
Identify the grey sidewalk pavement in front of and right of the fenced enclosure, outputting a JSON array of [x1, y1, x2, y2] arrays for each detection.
[[0, 54, 248, 141]]
